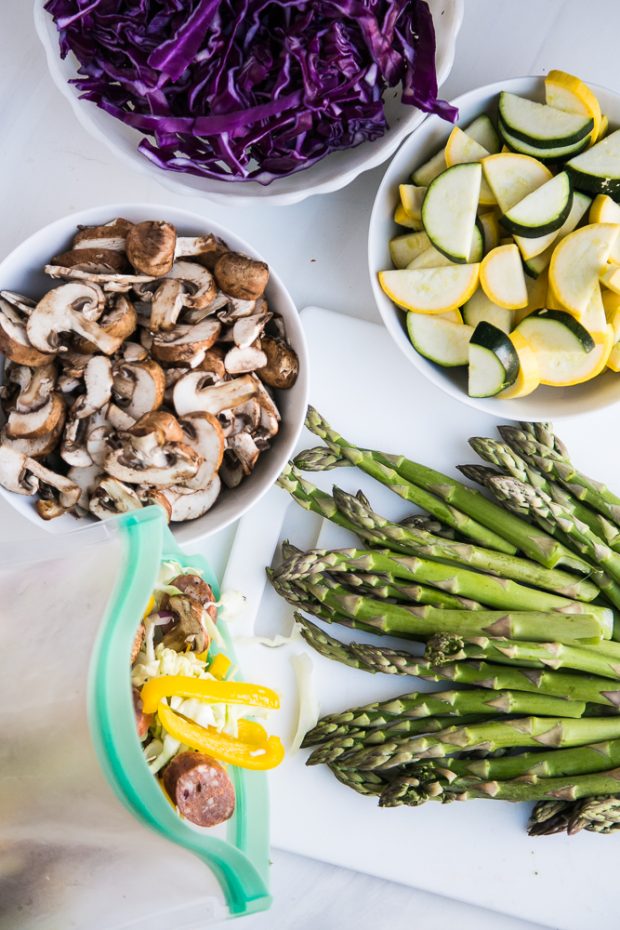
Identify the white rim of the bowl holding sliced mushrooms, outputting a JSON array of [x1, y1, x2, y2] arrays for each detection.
[[0, 201, 310, 545]]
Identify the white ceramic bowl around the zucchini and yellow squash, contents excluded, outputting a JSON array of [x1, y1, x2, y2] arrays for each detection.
[[368, 77, 620, 420]]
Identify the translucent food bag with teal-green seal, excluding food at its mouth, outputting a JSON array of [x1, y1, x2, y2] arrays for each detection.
[[0, 507, 270, 930]]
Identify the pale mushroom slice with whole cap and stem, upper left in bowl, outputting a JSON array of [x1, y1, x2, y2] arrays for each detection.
[[26, 282, 119, 355]]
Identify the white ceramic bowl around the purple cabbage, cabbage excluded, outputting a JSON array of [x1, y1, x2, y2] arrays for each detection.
[[34, 0, 464, 204]]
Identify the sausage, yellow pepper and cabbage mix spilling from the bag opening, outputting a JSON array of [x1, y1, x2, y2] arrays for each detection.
[[131, 562, 284, 827]]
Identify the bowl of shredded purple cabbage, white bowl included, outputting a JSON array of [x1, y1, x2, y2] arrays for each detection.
[[35, 0, 462, 203]]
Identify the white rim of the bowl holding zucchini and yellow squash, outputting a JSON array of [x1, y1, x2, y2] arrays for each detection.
[[367, 74, 620, 422]]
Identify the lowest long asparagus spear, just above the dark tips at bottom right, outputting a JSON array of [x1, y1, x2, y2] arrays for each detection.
[[379, 768, 620, 807]]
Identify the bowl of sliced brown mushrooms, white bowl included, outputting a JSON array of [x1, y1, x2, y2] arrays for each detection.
[[0, 204, 308, 542]]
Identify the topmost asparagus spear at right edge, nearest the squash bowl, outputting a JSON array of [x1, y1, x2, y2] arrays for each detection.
[[500, 426, 620, 525]]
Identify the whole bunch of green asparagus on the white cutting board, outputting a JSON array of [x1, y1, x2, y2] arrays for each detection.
[[268, 408, 620, 835]]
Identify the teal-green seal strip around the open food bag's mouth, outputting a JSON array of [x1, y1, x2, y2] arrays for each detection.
[[88, 507, 271, 916]]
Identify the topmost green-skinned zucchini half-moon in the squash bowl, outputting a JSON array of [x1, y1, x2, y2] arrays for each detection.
[[499, 91, 594, 149]]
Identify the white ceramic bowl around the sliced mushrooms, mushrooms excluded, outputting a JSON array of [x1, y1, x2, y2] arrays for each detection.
[[0, 203, 308, 544]]
